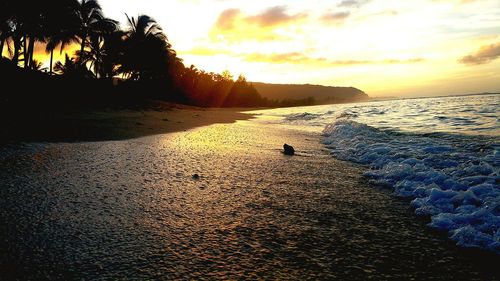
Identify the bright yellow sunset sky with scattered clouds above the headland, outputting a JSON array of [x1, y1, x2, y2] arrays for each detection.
[[19, 0, 500, 96]]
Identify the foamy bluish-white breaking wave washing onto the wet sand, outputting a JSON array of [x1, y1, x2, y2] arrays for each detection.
[[323, 115, 500, 253]]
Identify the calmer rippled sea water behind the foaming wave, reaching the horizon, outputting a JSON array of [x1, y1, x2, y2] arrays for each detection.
[[257, 94, 500, 138]]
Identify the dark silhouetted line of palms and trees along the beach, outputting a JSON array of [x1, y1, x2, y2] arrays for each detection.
[[0, 0, 316, 107]]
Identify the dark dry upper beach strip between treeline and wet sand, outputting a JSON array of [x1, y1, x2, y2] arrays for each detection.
[[0, 101, 253, 144]]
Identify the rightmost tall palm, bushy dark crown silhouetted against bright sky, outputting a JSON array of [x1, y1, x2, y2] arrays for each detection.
[[121, 15, 171, 80]]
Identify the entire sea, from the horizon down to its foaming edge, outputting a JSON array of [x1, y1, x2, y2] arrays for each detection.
[[254, 95, 500, 253]]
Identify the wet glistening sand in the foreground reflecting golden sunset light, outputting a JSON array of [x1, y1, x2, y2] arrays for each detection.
[[0, 111, 500, 280]]
